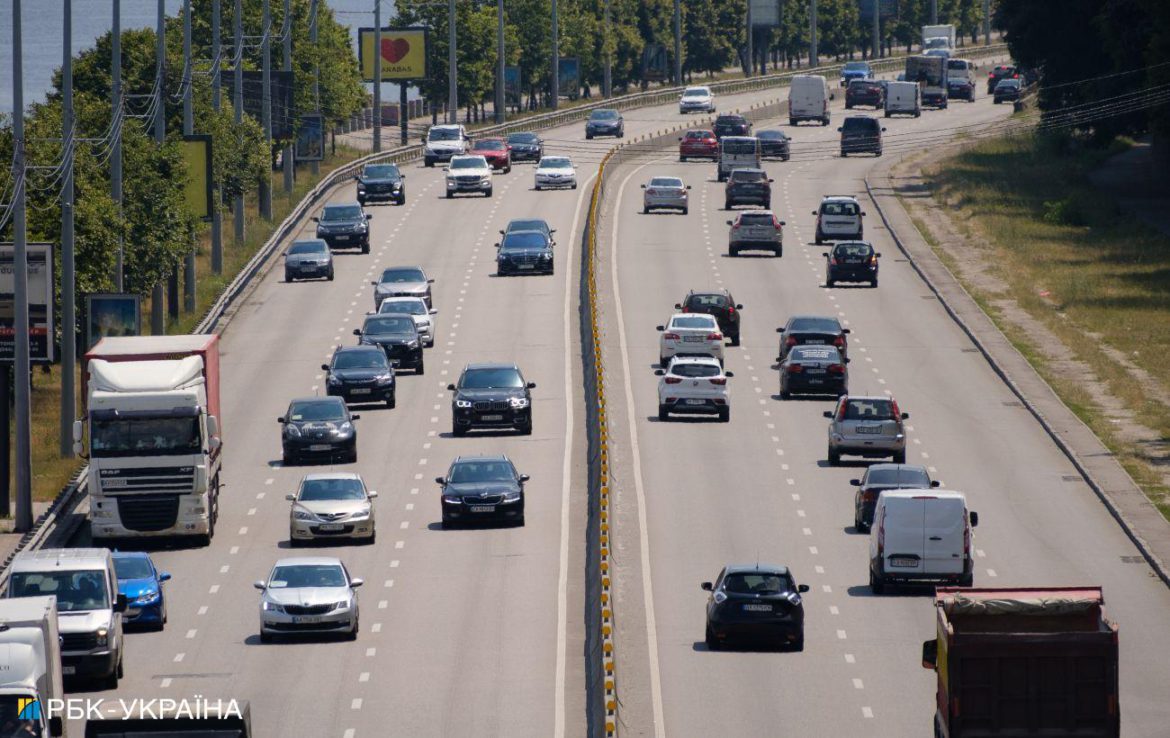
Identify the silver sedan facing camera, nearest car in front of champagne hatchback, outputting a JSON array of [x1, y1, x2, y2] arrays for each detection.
[[253, 556, 362, 643]]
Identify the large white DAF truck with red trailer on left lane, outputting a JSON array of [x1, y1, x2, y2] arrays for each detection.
[[73, 334, 222, 545]]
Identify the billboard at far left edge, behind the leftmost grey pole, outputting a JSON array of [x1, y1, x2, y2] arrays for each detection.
[[0, 243, 55, 364]]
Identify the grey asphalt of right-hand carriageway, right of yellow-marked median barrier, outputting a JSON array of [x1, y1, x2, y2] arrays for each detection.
[[598, 90, 1170, 738]]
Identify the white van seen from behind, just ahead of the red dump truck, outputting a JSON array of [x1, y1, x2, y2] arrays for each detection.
[[869, 489, 979, 594]]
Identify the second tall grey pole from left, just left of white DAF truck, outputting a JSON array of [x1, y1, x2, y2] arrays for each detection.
[[60, 0, 77, 458]]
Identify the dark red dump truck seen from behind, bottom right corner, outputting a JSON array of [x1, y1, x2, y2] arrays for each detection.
[[922, 587, 1121, 738]]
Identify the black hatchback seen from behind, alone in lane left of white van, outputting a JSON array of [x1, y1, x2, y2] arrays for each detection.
[[702, 564, 808, 650]]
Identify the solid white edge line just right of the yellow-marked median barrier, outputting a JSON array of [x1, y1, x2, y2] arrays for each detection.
[[610, 157, 666, 738]]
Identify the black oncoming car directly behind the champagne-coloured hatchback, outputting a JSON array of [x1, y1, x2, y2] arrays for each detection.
[[276, 398, 360, 465]]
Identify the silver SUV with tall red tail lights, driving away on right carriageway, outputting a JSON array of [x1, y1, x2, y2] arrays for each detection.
[[825, 395, 910, 467]]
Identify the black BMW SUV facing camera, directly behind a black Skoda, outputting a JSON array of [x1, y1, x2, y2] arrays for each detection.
[[447, 364, 536, 436]]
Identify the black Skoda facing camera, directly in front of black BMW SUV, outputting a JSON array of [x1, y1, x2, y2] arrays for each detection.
[[435, 455, 528, 527]]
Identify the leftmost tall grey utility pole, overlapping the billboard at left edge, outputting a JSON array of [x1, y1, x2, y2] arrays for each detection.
[[5, 0, 33, 533]]
